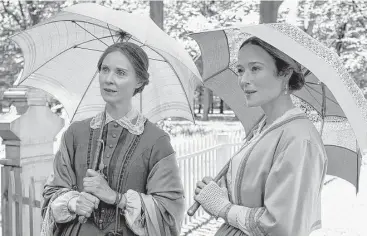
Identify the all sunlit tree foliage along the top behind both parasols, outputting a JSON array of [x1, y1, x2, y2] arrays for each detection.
[[0, 0, 367, 93]]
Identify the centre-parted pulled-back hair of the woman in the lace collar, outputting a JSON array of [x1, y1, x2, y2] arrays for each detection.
[[97, 42, 149, 95]]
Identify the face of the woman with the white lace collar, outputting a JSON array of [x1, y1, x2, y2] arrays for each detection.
[[99, 51, 140, 105]]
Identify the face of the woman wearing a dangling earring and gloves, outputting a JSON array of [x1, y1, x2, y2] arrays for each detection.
[[237, 44, 286, 107]]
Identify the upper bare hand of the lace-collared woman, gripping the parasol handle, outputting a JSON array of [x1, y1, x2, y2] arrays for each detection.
[[83, 169, 116, 204]]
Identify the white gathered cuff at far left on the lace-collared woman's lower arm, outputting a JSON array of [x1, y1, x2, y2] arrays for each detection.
[[51, 191, 79, 223]]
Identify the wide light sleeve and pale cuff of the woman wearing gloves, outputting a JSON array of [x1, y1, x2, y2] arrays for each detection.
[[227, 139, 326, 235]]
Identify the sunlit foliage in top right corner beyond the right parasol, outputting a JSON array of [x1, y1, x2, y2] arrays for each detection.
[[299, 0, 367, 89]]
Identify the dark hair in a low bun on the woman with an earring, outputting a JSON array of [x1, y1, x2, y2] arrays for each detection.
[[240, 37, 305, 91]]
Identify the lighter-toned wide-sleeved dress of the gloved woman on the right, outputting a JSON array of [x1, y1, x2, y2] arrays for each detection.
[[217, 109, 327, 235]]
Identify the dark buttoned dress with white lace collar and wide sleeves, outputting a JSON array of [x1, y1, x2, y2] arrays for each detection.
[[42, 110, 184, 235]]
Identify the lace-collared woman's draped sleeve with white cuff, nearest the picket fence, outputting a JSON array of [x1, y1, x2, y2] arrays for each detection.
[[124, 136, 184, 236]]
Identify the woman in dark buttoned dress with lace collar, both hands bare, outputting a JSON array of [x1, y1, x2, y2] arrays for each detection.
[[42, 42, 184, 236]]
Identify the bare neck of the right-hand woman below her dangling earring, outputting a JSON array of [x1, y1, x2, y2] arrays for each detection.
[[261, 95, 295, 124]]
